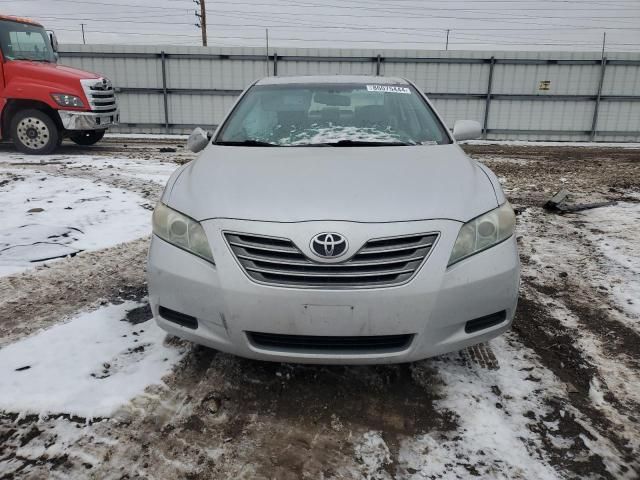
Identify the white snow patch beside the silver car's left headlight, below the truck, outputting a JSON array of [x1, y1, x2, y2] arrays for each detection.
[[0, 170, 151, 276]]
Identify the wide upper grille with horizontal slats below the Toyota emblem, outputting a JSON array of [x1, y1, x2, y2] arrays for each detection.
[[225, 232, 438, 289]]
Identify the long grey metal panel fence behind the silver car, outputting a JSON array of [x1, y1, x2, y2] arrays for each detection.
[[61, 45, 640, 141]]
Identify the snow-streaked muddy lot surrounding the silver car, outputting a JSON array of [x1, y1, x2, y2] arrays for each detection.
[[0, 139, 640, 480]]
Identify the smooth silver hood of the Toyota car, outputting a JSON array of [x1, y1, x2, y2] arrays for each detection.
[[163, 145, 498, 222]]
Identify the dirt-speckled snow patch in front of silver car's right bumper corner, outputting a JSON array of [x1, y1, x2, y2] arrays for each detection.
[[354, 334, 634, 480]]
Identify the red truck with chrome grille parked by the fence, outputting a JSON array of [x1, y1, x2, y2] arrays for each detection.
[[0, 15, 119, 154]]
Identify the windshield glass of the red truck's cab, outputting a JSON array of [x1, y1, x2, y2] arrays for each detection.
[[0, 20, 55, 62]]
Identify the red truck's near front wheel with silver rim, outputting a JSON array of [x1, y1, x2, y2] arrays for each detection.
[[10, 110, 60, 155]]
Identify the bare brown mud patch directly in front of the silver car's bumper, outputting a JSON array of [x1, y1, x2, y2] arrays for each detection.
[[79, 347, 456, 479]]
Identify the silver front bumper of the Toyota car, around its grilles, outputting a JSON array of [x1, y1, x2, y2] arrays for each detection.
[[148, 220, 520, 364]]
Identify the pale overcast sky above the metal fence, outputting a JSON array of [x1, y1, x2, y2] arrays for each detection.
[[5, 0, 640, 52]]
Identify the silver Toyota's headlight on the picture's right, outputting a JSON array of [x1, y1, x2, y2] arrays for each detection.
[[447, 202, 516, 266]]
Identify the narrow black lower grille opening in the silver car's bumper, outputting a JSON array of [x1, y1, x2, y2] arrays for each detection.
[[247, 332, 413, 353]]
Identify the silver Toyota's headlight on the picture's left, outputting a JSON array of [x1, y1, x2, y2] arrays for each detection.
[[153, 202, 213, 263]]
